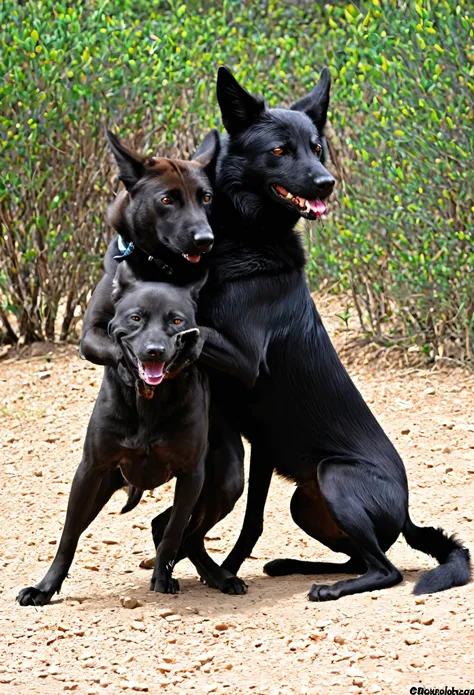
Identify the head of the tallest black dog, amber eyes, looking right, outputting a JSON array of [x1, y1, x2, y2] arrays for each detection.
[[217, 67, 335, 220]]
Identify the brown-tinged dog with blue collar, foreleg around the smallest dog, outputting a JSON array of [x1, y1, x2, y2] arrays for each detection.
[[81, 131, 219, 366]]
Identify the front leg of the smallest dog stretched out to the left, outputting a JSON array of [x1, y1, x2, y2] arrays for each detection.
[[17, 456, 124, 606]]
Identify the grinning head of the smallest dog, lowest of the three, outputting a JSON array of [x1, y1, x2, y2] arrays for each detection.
[[109, 261, 207, 387]]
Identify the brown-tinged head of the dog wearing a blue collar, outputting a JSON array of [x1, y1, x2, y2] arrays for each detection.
[[107, 131, 219, 263]]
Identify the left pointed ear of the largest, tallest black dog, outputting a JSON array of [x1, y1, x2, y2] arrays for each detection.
[[217, 67, 265, 135]]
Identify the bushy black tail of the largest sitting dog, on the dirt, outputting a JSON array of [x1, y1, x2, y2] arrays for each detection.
[[402, 516, 471, 594]]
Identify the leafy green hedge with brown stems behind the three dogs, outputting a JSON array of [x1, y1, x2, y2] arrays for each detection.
[[0, 0, 474, 360]]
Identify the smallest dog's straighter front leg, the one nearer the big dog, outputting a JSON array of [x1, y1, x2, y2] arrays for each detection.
[[150, 457, 205, 594]]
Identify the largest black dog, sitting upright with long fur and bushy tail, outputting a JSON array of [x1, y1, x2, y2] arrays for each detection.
[[153, 68, 470, 601]]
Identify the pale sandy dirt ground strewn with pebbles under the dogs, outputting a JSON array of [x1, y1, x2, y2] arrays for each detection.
[[0, 303, 474, 695]]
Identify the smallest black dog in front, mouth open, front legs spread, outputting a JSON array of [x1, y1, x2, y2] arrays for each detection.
[[17, 263, 209, 606]]
